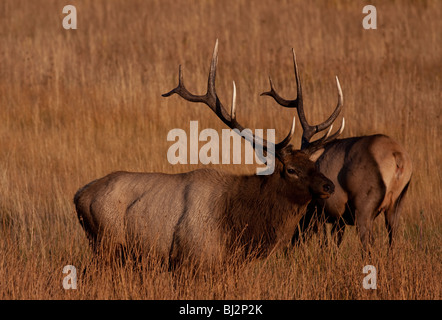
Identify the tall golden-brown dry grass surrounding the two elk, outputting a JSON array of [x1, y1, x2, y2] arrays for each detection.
[[0, 0, 442, 299]]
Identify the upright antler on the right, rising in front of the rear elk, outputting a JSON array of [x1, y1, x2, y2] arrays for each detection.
[[261, 49, 345, 149]]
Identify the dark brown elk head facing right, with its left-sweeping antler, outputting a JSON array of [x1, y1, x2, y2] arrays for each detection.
[[163, 40, 334, 203]]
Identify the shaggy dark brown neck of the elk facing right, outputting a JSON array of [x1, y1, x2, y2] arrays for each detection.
[[222, 165, 309, 255]]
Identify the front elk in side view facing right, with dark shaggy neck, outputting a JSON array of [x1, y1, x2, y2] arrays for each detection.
[[74, 41, 342, 267]]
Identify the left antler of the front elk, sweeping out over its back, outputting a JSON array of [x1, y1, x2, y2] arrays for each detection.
[[163, 39, 295, 150]]
